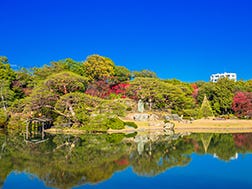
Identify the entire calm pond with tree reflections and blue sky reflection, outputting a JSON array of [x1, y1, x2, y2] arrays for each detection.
[[0, 128, 252, 189]]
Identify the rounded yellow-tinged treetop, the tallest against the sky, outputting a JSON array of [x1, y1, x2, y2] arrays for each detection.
[[84, 55, 115, 81]]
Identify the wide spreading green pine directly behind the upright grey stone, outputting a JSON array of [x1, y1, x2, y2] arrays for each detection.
[[127, 77, 194, 112]]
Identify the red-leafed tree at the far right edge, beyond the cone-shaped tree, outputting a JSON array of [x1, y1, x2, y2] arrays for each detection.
[[232, 92, 252, 118]]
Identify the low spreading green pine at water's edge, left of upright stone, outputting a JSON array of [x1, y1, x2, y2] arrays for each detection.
[[55, 92, 126, 129]]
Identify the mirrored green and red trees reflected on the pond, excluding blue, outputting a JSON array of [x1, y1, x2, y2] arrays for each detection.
[[0, 130, 252, 188]]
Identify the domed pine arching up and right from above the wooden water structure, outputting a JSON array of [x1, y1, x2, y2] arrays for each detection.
[[25, 71, 87, 118]]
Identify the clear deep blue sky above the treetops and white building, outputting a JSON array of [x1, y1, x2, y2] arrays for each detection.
[[0, 0, 252, 81]]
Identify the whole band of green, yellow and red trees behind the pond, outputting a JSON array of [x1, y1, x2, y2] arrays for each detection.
[[0, 55, 252, 130]]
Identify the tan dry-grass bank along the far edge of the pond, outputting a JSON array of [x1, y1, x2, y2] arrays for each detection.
[[46, 119, 252, 134]]
